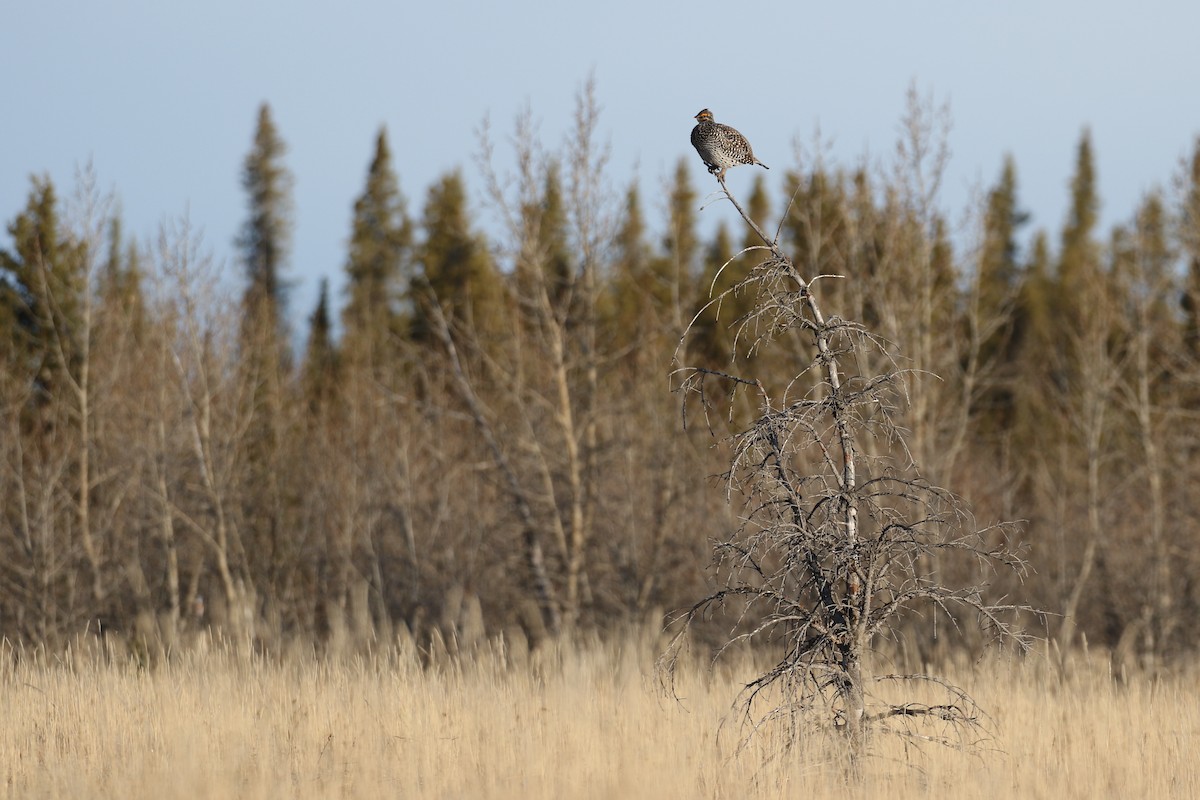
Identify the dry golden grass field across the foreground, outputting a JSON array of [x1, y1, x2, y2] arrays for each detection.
[[0, 637, 1200, 800]]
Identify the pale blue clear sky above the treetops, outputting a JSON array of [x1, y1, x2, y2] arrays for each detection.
[[0, 0, 1200, 329]]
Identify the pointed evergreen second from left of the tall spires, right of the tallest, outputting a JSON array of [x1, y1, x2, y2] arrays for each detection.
[[342, 128, 413, 366]]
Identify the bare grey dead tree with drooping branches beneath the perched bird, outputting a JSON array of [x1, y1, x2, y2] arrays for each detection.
[[664, 172, 1027, 757]]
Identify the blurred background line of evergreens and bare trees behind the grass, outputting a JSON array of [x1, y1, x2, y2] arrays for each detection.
[[0, 86, 1200, 660]]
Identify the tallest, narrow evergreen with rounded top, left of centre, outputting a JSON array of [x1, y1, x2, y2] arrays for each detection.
[[238, 103, 293, 343]]
